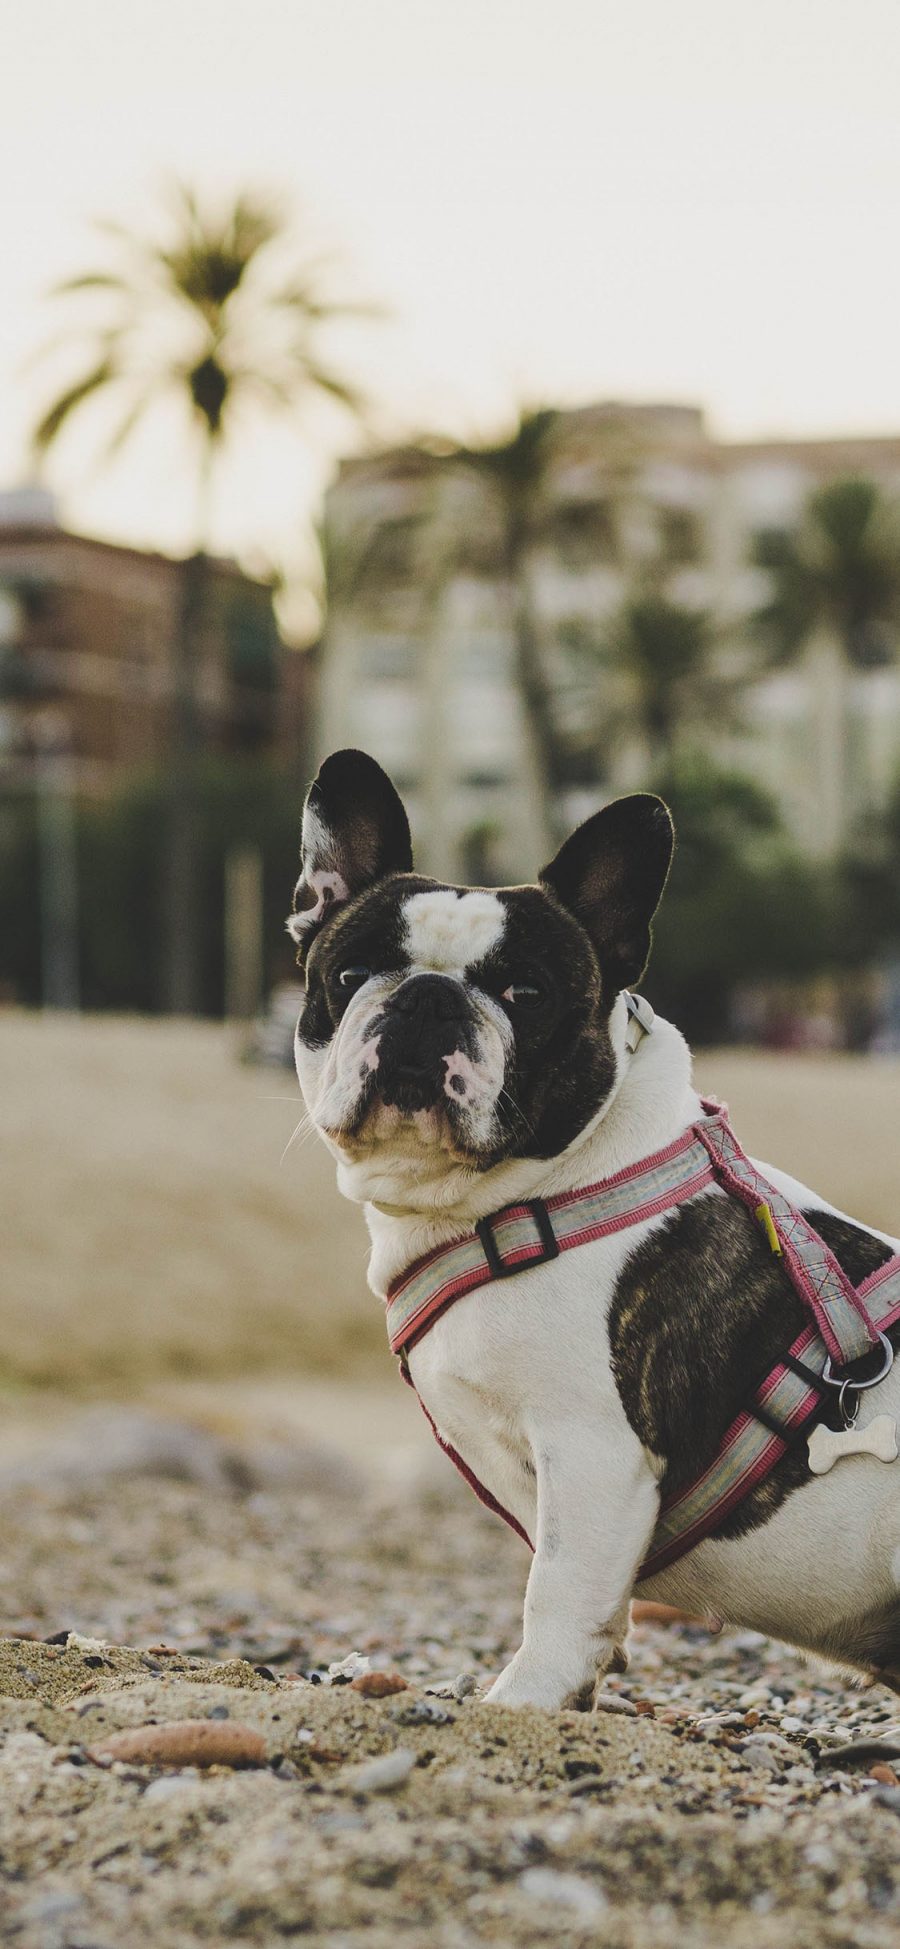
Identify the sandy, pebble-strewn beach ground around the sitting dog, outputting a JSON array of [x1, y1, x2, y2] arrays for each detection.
[[0, 1013, 900, 1949]]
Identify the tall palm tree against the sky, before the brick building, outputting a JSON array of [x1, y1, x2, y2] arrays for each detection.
[[33, 183, 364, 1012]]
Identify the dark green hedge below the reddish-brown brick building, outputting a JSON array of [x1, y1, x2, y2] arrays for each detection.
[[0, 758, 302, 1015]]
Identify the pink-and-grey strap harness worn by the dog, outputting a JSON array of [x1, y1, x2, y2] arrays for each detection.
[[386, 1036, 900, 1583]]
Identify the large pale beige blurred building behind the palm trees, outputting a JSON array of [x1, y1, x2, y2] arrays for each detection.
[[318, 405, 900, 879]]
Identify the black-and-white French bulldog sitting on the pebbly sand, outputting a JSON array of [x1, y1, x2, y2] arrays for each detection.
[[288, 750, 900, 1711]]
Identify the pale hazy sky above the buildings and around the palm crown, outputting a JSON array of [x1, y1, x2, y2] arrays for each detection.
[[0, 0, 900, 619]]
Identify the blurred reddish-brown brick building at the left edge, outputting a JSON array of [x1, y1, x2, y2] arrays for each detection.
[[0, 489, 310, 793]]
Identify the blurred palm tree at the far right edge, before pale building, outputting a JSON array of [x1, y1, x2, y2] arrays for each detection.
[[754, 478, 900, 854]]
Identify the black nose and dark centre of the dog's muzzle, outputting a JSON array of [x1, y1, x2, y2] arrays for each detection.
[[378, 975, 471, 1111]]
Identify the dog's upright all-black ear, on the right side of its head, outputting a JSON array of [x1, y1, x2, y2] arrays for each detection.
[[540, 791, 674, 994]]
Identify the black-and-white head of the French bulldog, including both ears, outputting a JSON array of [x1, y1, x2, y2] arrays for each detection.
[[288, 752, 672, 1171]]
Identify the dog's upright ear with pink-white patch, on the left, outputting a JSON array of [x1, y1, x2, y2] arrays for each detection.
[[288, 750, 413, 949]]
